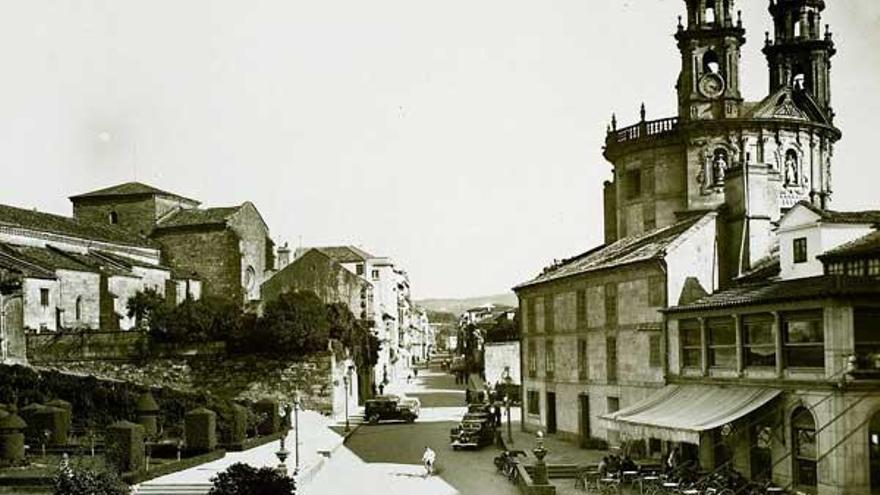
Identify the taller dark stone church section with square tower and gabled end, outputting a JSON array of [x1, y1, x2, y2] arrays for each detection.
[[70, 182, 275, 308]]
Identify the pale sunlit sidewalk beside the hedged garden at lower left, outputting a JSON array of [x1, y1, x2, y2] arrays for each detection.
[[134, 411, 344, 495]]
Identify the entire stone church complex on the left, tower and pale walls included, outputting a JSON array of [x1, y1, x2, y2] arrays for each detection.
[[0, 182, 275, 362]]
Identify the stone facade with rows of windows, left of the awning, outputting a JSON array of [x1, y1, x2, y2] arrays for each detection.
[[520, 262, 665, 446]]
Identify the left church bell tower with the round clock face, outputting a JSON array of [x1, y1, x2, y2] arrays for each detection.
[[675, 0, 746, 121]]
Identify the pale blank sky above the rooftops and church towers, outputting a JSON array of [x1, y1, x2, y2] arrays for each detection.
[[0, 0, 880, 297]]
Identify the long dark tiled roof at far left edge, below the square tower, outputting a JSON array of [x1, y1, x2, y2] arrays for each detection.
[[0, 205, 155, 248]]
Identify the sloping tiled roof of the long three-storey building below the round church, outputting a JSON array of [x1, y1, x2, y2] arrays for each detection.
[[515, 213, 714, 289]]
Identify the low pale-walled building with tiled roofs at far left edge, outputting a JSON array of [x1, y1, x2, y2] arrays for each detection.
[[0, 205, 200, 361]]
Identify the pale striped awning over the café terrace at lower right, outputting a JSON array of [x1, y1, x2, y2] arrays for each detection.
[[601, 385, 782, 445]]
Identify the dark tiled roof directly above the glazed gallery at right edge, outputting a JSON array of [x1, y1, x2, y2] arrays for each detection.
[[666, 275, 880, 313]]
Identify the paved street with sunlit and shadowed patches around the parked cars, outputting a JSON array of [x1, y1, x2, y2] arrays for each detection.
[[303, 369, 518, 495]]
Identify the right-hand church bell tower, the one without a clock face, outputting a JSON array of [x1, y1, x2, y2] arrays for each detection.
[[764, 0, 836, 121]]
